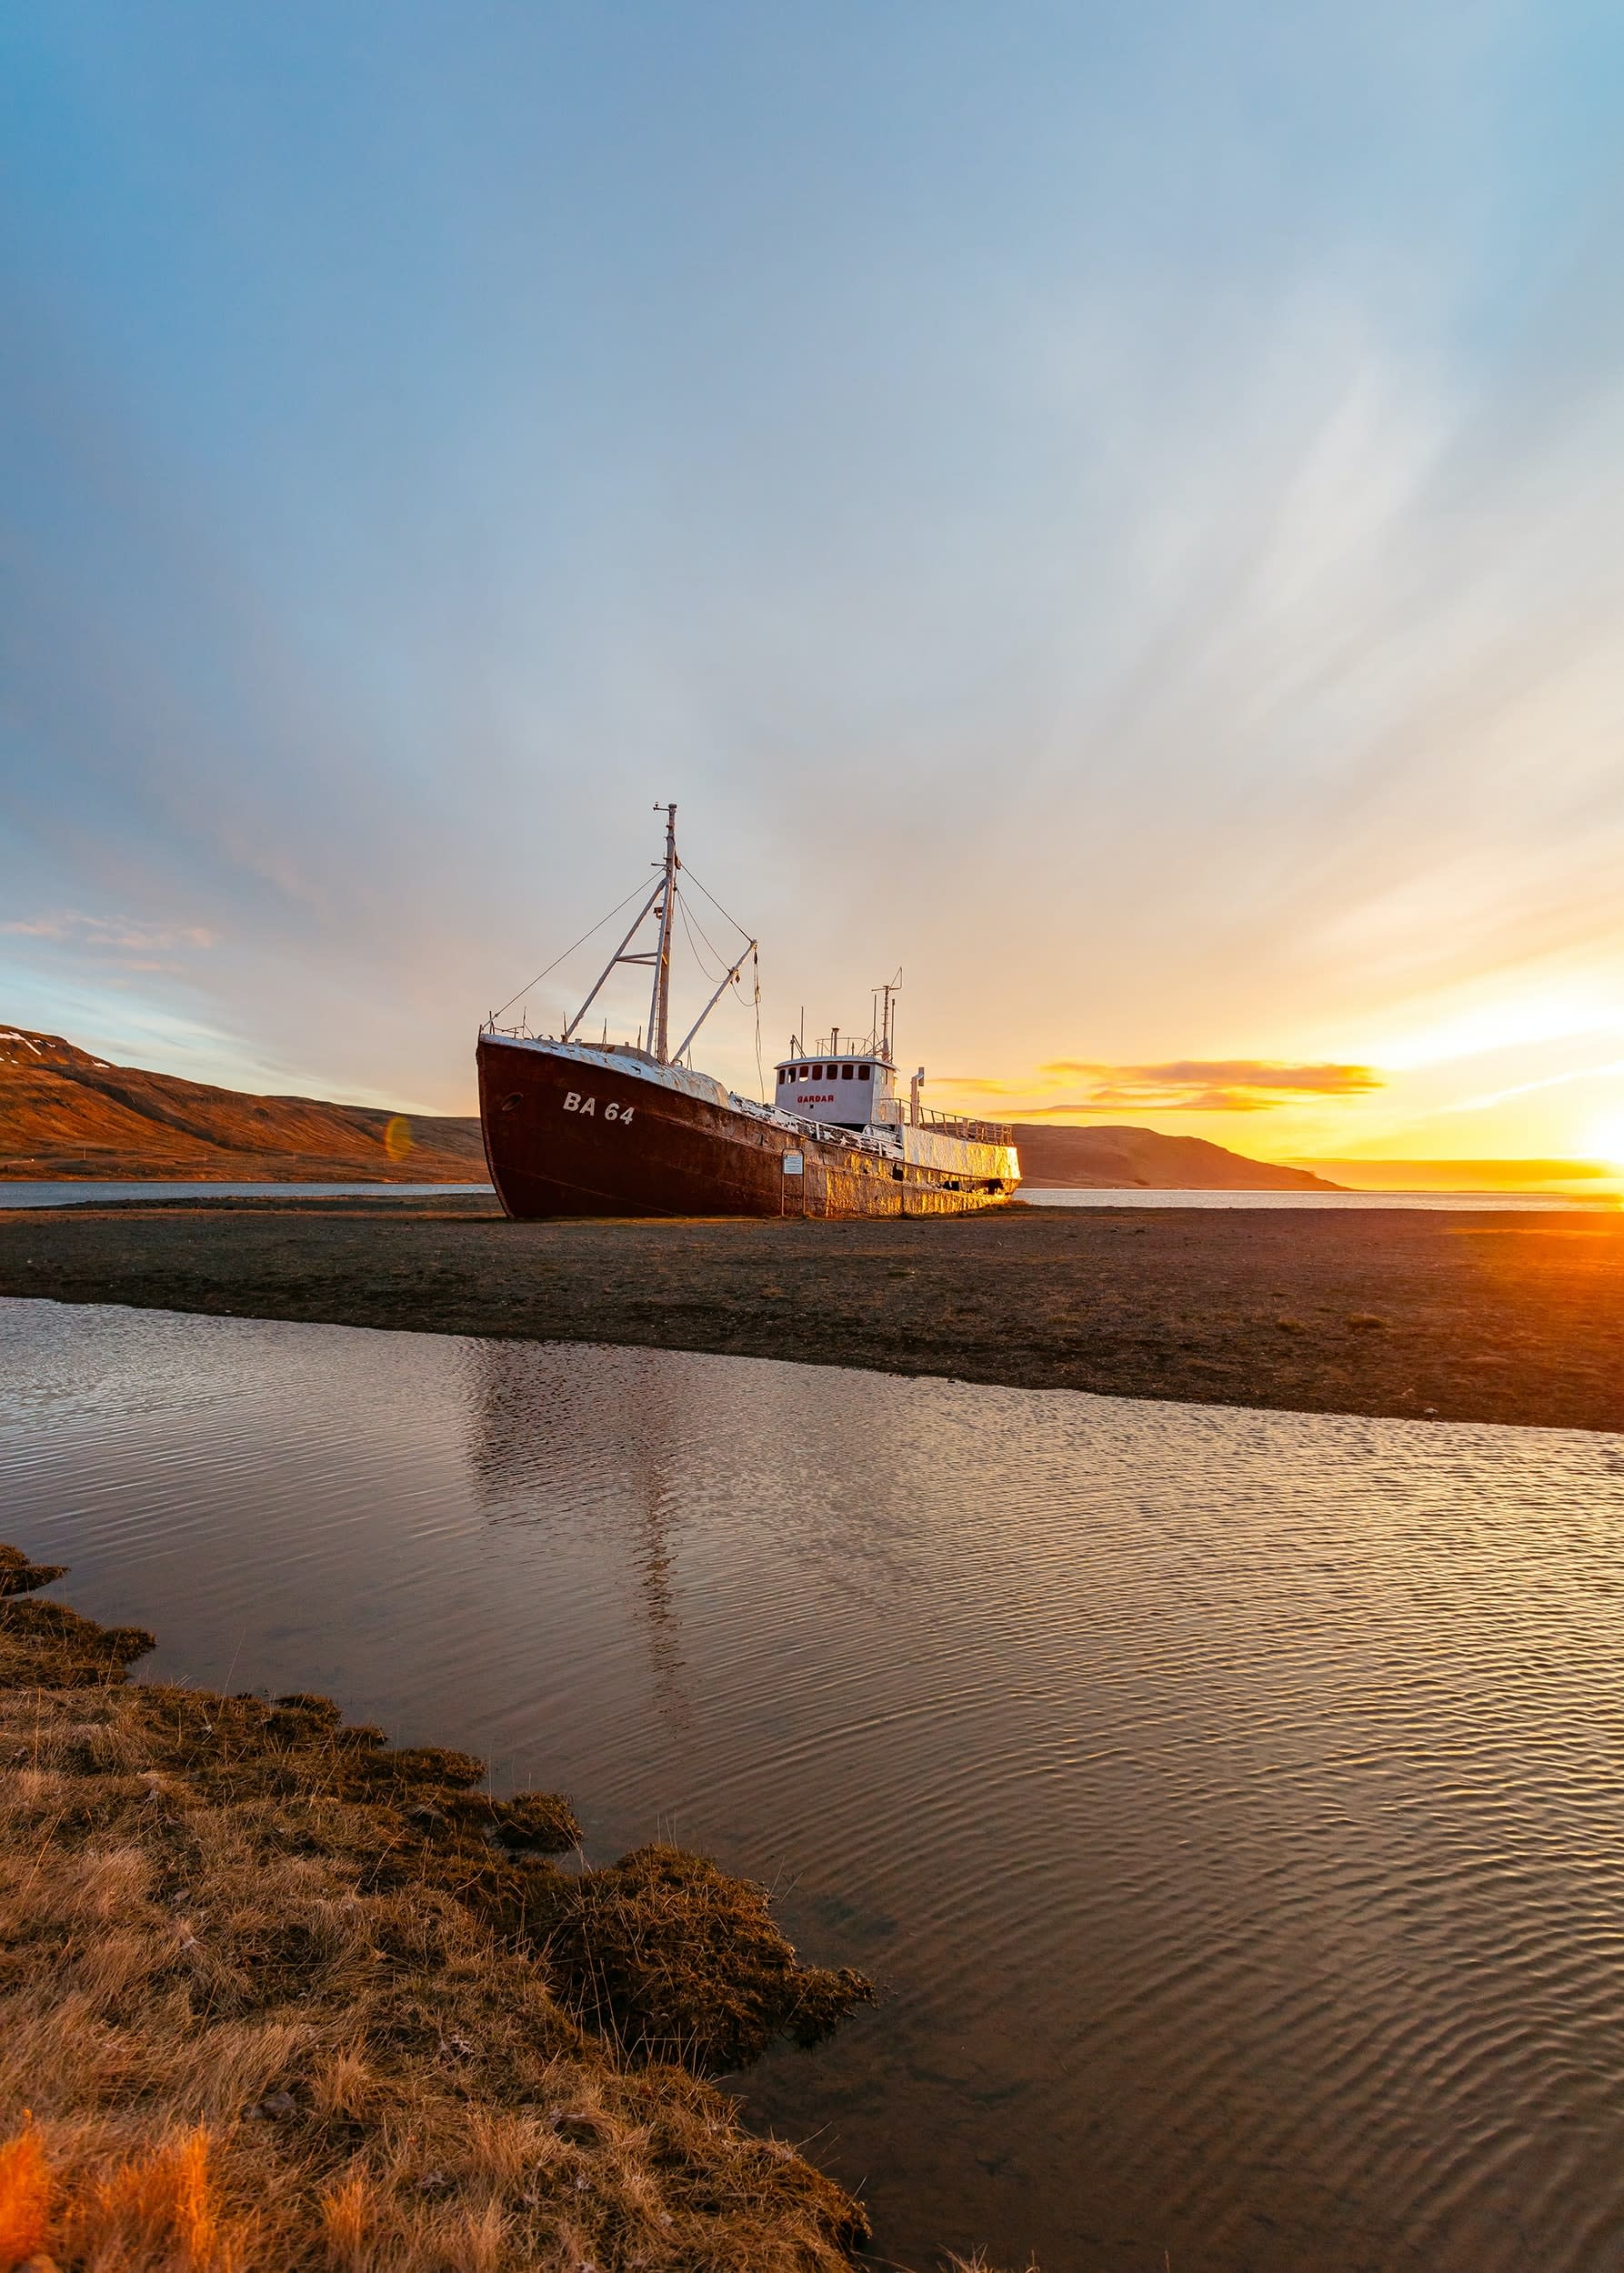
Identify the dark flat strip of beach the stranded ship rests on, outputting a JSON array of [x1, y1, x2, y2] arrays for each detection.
[[0, 1194, 1624, 1432]]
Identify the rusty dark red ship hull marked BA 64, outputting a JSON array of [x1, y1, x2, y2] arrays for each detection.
[[477, 1032, 1019, 1218]]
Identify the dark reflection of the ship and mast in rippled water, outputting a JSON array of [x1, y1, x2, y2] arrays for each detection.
[[464, 1341, 691, 1732]]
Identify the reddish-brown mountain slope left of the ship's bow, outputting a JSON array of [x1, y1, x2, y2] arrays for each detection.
[[0, 1027, 485, 1185]]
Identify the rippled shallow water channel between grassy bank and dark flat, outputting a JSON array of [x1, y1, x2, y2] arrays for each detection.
[[0, 1300, 1624, 2273]]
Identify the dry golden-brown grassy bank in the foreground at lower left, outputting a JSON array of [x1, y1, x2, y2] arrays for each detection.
[[0, 1550, 869, 2273]]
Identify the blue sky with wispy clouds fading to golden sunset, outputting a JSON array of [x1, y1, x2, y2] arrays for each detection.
[[0, 0, 1624, 1168]]
